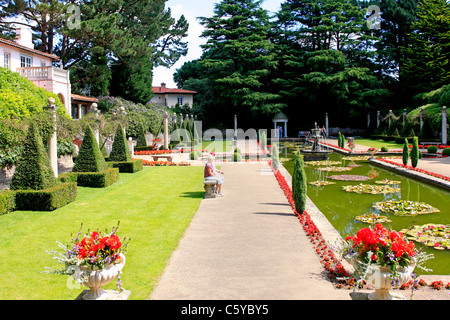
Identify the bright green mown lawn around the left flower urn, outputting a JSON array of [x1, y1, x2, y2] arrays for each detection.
[[0, 167, 204, 300]]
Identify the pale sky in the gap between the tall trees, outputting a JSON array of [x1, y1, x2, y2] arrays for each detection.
[[153, 0, 284, 88]]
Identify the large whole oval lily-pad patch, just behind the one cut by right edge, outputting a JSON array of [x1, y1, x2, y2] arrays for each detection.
[[374, 200, 440, 216]]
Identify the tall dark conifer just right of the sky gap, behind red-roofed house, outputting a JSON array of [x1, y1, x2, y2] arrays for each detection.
[[200, 0, 280, 114]]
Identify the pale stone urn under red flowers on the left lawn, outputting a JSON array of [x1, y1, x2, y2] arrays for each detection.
[[73, 254, 126, 300]]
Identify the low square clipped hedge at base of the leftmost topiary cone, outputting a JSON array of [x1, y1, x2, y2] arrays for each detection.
[[15, 182, 77, 211]]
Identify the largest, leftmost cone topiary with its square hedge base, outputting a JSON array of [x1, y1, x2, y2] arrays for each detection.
[[10, 124, 77, 211]]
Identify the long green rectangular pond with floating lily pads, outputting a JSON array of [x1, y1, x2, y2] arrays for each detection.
[[280, 142, 450, 275]]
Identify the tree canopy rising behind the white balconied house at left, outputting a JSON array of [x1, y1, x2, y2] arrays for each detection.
[[0, 0, 189, 103]]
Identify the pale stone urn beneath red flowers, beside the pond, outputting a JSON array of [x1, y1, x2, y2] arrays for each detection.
[[366, 261, 416, 300]]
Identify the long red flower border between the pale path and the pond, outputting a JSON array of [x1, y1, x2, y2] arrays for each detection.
[[268, 161, 450, 300]]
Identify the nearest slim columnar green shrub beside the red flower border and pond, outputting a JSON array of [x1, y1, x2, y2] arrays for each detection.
[[292, 152, 307, 214]]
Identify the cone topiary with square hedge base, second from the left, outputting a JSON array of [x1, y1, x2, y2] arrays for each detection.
[[72, 126, 119, 188]]
